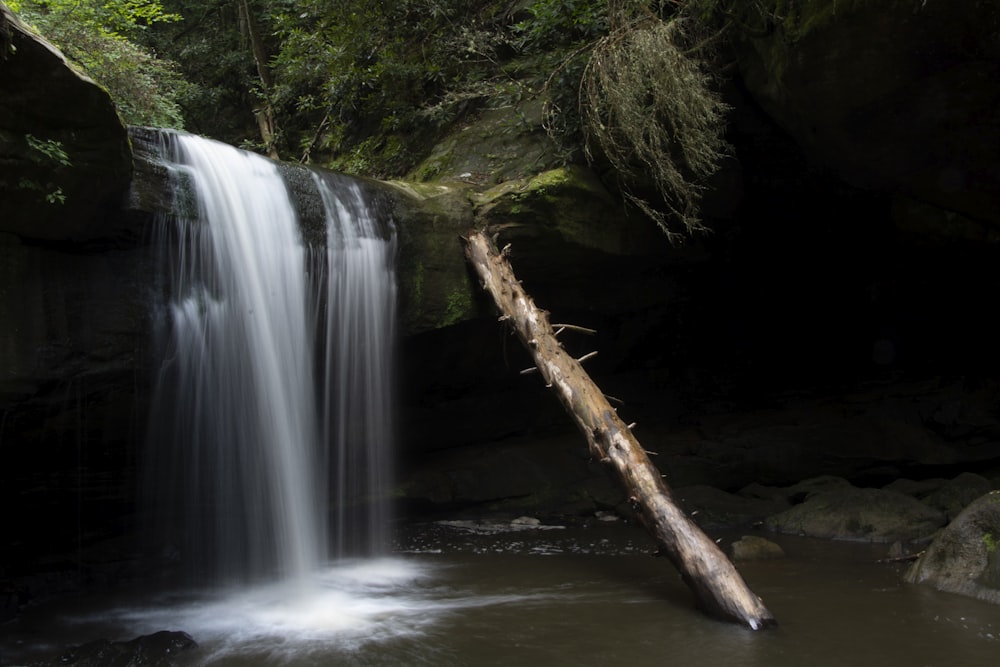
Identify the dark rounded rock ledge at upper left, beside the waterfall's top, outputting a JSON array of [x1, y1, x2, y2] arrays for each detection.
[[0, 3, 133, 242]]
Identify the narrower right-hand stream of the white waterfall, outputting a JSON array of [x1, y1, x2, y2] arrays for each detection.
[[313, 173, 396, 557]]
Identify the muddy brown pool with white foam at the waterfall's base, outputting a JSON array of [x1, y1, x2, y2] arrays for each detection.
[[0, 524, 1000, 667]]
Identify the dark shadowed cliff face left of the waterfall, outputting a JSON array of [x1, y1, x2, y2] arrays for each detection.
[[0, 3, 148, 593]]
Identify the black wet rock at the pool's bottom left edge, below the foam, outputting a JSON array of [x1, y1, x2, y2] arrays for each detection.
[[50, 630, 198, 667]]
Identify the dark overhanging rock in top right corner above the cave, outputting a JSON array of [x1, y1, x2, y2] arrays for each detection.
[[737, 0, 1000, 236]]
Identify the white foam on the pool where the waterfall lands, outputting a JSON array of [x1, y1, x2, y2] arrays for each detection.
[[84, 557, 551, 664]]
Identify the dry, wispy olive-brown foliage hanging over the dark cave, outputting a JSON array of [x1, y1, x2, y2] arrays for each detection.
[[580, 0, 727, 241]]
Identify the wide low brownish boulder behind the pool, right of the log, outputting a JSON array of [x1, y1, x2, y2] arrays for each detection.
[[764, 488, 945, 542]]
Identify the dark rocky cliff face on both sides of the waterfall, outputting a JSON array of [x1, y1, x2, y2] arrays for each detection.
[[0, 2, 1000, 584]]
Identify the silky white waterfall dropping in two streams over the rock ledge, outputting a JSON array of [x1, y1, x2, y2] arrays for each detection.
[[147, 133, 396, 580]]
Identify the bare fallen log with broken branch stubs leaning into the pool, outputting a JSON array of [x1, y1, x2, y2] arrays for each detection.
[[465, 232, 775, 630]]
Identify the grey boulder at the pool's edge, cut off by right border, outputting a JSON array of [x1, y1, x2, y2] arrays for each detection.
[[904, 491, 1000, 604]]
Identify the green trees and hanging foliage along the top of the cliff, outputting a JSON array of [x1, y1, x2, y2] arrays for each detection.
[[5, 0, 757, 236]]
